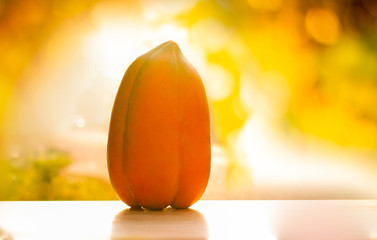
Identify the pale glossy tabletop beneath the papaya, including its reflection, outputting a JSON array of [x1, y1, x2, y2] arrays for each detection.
[[0, 200, 377, 240]]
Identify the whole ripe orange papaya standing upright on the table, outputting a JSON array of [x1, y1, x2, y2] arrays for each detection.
[[107, 41, 211, 209]]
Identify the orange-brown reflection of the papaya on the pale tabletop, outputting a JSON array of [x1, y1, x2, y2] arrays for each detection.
[[111, 208, 208, 240]]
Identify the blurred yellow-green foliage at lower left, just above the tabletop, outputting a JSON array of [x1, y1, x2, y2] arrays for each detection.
[[0, 149, 117, 201]]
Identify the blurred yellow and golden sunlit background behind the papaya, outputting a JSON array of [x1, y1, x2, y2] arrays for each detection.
[[0, 0, 377, 200]]
